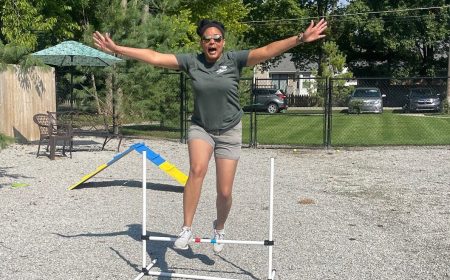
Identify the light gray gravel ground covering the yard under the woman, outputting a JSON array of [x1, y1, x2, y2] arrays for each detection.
[[0, 138, 450, 280]]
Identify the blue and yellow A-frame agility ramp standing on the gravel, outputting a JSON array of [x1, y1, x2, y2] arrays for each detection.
[[69, 143, 188, 190]]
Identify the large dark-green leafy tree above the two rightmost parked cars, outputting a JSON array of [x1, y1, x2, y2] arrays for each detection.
[[338, 0, 450, 77]]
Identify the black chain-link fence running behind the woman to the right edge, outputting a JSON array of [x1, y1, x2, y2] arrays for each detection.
[[181, 77, 450, 148]]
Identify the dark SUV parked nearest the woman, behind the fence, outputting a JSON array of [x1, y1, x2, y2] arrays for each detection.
[[242, 88, 288, 114]]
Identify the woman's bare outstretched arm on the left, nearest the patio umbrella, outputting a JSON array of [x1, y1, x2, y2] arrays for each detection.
[[92, 31, 179, 70]]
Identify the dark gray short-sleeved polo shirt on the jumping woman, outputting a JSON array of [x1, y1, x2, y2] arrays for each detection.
[[176, 50, 249, 131]]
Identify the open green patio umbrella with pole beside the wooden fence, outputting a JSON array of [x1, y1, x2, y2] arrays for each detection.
[[32, 41, 122, 107]]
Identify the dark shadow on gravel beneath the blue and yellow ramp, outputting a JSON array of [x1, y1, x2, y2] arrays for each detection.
[[74, 180, 184, 193]]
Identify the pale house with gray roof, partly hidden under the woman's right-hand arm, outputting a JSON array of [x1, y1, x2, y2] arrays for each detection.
[[253, 53, 317, 96]]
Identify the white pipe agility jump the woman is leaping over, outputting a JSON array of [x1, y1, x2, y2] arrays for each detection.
[[134, 150, 275, 280]]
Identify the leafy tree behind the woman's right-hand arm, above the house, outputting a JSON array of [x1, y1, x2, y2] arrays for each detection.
[[245, 0, 345, 77]]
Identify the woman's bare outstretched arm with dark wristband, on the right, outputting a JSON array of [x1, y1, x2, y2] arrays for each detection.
[[247, 19, 327, 67]]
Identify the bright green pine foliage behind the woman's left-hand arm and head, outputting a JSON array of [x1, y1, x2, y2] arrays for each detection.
[[86, 0, 251, 125]]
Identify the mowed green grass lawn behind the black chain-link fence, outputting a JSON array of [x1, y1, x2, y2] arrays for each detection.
[[122, 110, 450, 146]]
